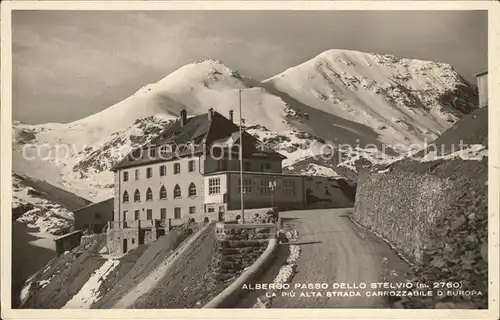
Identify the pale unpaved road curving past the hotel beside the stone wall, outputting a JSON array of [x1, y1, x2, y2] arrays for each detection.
[[242, 209, 409, 308]]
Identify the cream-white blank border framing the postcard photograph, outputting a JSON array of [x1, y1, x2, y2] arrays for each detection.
[[0, 1, 500, 319]]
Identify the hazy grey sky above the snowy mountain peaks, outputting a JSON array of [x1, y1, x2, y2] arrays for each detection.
[[12, 11, 488, 124]]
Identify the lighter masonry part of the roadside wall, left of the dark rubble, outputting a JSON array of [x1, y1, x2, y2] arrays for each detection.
[[353, 170, 453, 261]]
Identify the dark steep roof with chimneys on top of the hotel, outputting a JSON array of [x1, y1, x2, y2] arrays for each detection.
[[111, 111, 286, 171]]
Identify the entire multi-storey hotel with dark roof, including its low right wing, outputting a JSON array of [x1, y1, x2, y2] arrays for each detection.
[[107, 109, 354, 255]]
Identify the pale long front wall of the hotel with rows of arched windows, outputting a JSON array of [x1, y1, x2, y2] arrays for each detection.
[[114, 156, 204, 221]]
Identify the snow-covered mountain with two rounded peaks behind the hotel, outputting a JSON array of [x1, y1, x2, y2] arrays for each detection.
[[13, 50, 477, 200]]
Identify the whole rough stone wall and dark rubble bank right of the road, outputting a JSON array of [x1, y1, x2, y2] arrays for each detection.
[[353, 158, 488, 309]]
